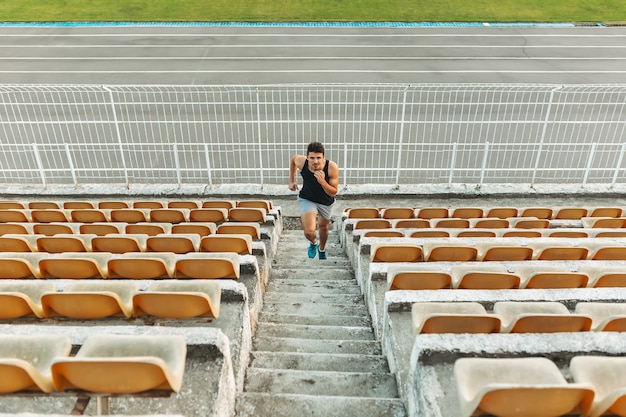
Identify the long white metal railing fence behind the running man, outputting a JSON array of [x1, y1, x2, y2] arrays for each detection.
[[0, 84, 626, 192]]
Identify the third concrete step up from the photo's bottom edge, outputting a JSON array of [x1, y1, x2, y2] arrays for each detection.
[[250, 352, 389, 373]]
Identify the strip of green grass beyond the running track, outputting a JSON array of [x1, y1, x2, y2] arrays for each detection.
[[0, 0, 626, 22]]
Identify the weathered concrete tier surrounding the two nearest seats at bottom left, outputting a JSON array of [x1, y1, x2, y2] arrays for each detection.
[[0, 325, 236, 417]]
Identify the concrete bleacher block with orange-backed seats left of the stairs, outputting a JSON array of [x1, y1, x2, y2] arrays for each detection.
[[0, 200, 282, 416]]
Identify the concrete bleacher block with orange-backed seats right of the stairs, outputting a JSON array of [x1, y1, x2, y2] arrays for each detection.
[[338, 203, 626, 417]]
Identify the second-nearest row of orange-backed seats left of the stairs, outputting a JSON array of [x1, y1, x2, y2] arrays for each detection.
[[0, 280, 222, 318]]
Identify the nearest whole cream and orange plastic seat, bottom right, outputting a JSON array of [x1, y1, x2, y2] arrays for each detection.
[[454, 358, 594, 417]]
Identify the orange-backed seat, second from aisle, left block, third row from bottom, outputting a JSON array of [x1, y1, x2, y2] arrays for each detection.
[[107, 252, 176, 279]]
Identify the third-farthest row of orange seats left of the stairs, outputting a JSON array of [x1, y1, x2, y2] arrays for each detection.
[[0, 222, 261, 239]]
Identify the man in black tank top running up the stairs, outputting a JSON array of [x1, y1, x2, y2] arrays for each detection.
[[289, 142, 339, 259]]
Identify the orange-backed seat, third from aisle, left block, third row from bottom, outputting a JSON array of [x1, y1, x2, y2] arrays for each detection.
[[39, 252, 111, 279]]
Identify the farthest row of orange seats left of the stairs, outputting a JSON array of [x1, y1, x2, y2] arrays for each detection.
[[0, 200, 274, 211]]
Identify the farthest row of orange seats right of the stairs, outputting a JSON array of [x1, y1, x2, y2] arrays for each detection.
[[343, 207, 623, 220]]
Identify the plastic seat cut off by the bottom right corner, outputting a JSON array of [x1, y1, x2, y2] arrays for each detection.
[[569, 356, 626, 417]]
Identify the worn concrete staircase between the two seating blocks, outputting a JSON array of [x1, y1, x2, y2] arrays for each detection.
[[237, 230, 406, 417]]
